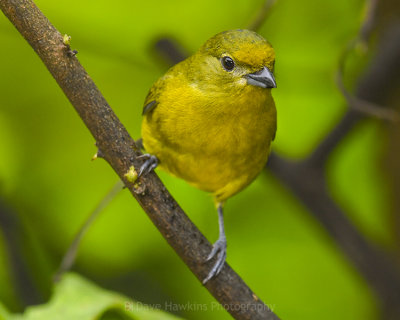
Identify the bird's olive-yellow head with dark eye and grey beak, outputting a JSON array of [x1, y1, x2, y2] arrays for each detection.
[[191, 30, 276, 92]]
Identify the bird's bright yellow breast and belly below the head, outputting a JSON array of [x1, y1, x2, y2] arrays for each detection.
[[142, 84, 276, 202]]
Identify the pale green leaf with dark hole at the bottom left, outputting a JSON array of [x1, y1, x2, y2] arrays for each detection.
[[0, 273, 180, 320]]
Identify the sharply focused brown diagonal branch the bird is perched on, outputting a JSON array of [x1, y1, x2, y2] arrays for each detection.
[[0, 0, 278, 319]]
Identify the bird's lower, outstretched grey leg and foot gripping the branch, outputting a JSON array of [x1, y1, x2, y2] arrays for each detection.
[[203, 203, 227, 284]]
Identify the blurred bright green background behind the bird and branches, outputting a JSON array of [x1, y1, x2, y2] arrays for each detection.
[[0, 0, 394, 320]]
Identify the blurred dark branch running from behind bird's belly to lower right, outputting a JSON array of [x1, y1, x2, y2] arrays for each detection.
[[268, 154, 400, 319]]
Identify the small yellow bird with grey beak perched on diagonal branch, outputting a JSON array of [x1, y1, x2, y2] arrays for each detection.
[[139, 30, 276, 283]]
